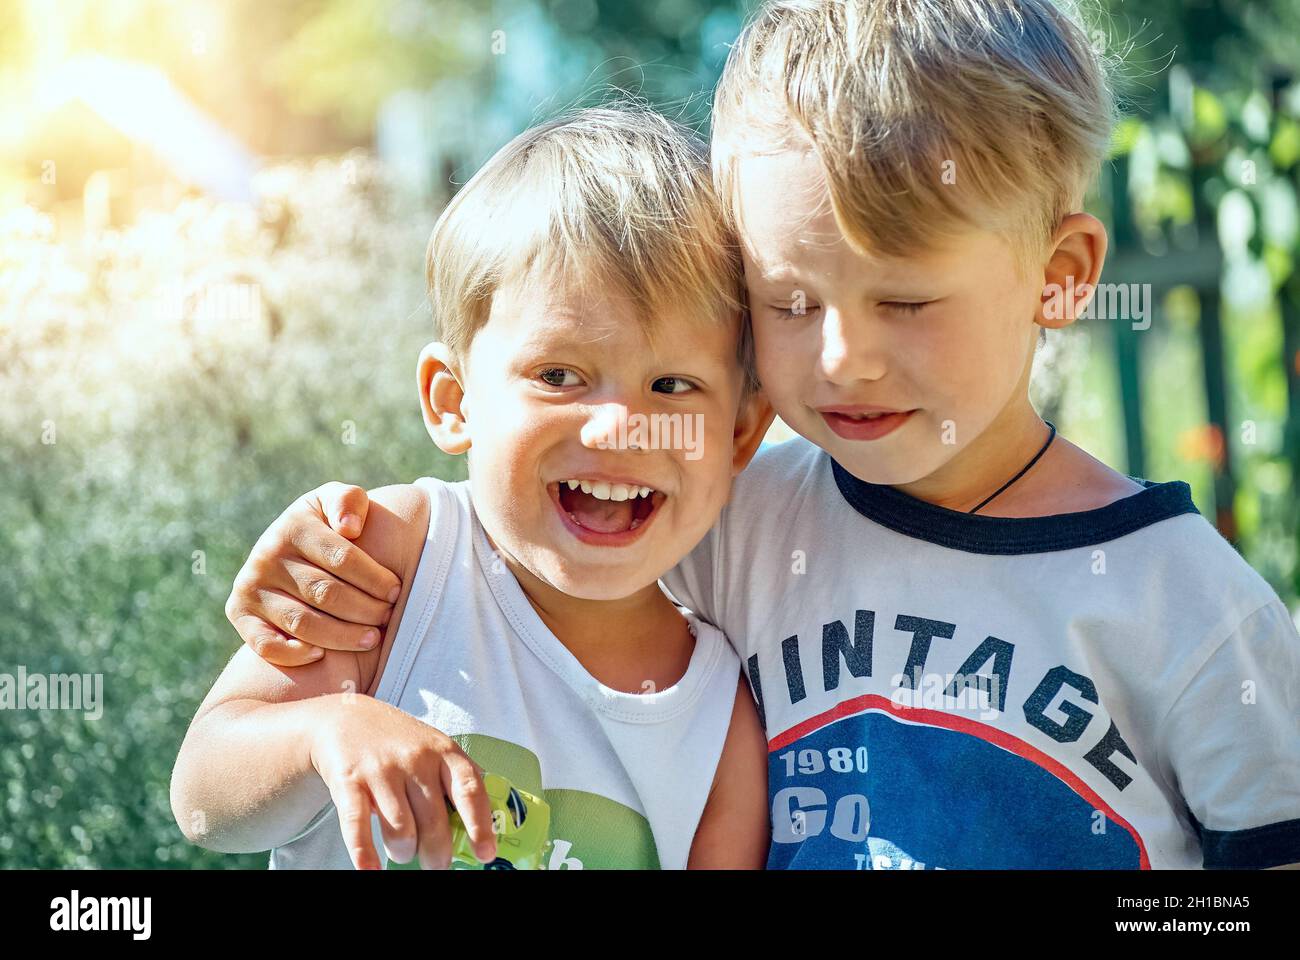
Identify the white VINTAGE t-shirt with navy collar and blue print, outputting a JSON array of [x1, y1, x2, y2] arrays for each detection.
[[664, 440, 1300, 870]]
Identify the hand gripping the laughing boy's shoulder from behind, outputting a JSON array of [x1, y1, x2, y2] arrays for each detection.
[[226, 481, 402, 666]]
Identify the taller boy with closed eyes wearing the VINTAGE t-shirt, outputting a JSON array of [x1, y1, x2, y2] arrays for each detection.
[[218, 0, 1300, 869]]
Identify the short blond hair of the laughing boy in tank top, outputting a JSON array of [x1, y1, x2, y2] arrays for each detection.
[[426, 105, 754, 386]]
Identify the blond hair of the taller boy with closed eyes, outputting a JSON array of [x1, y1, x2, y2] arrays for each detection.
[[714, 0, 1114, 264]]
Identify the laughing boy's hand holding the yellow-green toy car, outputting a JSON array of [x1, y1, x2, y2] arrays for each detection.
[[311, 693, 497, 870]]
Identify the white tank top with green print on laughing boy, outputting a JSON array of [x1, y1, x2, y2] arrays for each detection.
[[270, 477, 740, 870]]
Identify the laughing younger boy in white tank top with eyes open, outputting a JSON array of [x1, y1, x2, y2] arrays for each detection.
[[172, 109, 771, 869]]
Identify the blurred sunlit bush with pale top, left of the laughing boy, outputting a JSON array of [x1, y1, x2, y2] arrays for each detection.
[[0, 156, 463, 868]]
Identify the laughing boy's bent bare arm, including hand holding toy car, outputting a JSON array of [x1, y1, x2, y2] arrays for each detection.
[[172, 487, 493, 866]]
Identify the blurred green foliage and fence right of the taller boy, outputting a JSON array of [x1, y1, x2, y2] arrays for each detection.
[[1097, 0, 1300, 590]]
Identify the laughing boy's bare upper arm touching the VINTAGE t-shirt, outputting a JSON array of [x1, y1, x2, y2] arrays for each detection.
[[686, 678, 772, 870]]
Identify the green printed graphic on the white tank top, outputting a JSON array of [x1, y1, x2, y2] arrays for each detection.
[[389, 734, 659, 870]]
